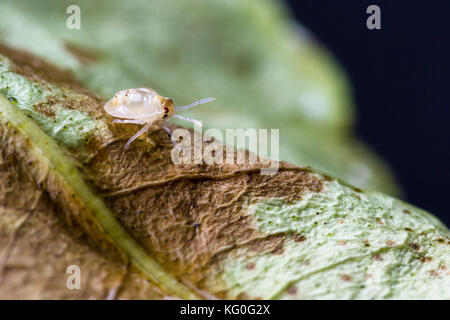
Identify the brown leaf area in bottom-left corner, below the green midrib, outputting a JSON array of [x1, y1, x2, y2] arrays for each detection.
[[0, 128, 165, 299]]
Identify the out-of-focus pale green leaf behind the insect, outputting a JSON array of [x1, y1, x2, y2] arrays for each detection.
[[0, 0, 399, 195]]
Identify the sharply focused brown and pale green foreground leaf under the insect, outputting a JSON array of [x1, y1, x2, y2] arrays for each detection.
[[0, 46, 450, 299]]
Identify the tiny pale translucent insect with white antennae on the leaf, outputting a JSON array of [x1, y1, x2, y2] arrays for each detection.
[[104, 88, 216, 149]]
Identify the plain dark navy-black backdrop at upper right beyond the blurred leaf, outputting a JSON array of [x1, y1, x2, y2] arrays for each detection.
[[287, 0, 450, 226]]
